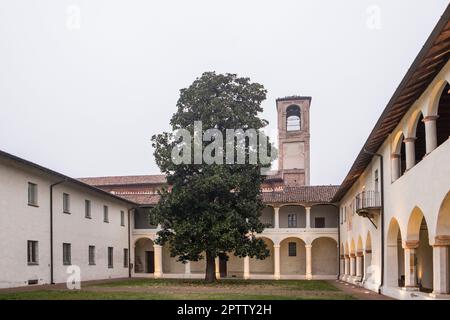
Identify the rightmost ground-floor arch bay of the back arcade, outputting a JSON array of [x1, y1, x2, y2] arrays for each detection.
[[312, 237, 337, 276]]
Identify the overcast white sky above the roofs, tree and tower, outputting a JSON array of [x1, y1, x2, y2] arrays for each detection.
[[0, 0, 448, 184]]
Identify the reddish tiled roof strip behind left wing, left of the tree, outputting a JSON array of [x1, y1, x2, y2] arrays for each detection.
[[78, 174, 167, 187]]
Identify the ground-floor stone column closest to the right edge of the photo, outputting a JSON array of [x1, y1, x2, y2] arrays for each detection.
[[433, 240, 450, 295]]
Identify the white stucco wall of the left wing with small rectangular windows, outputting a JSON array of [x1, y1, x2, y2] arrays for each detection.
[[0, 159, 133, 287]]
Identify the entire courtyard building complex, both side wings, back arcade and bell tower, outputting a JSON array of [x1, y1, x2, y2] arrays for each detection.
[[0, 8, 450, 299]]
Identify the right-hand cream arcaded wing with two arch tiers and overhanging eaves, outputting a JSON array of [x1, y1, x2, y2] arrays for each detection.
[[333, 9, 450, 299]]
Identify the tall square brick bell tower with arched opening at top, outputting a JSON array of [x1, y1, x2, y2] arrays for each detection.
[[276, 96, 311, 186]]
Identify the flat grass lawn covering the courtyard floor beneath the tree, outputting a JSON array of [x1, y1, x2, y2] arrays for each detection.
[[0, 279, 354, 300]]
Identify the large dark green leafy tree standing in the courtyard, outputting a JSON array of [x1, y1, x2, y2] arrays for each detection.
[[152, 72, 276, 281]]
